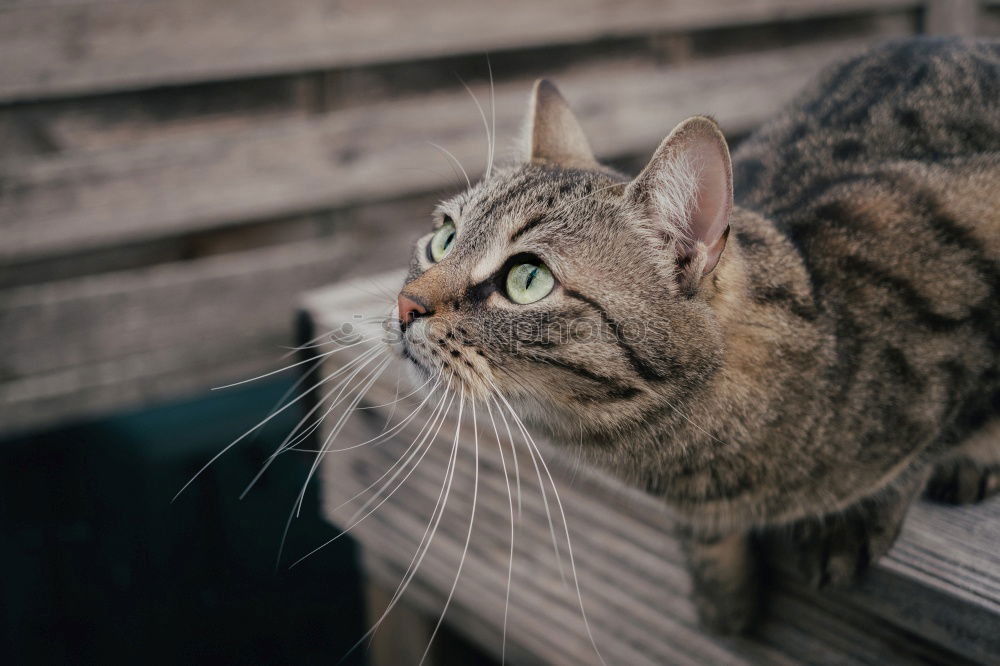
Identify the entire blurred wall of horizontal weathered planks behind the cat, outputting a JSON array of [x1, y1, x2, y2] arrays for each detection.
[[0, 0, 1000, 432]]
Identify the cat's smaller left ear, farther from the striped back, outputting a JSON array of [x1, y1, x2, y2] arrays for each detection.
[[523, 79, 599, 169]]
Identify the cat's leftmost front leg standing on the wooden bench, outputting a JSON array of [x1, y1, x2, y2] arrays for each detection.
[[680, 533, 760, 634]]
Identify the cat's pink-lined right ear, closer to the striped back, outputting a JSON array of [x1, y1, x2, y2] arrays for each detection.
[[625, 116, 733, 286]]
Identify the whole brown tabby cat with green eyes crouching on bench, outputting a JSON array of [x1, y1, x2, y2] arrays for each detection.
[[393, 38, 1000, 633]]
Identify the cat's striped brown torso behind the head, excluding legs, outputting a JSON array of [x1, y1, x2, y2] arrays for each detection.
[[600, 40, 1000, 528]]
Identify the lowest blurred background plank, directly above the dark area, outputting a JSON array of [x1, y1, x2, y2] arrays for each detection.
[[0, 199, 418, 431]]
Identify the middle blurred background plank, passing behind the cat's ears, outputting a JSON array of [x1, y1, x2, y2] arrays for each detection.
[[0, 40, 896, 262]]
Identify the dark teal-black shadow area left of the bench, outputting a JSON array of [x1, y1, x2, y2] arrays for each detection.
[[0, 380, 364, 664]]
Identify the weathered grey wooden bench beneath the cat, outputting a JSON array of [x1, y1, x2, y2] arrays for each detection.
[[299, 273, 1000, 666]]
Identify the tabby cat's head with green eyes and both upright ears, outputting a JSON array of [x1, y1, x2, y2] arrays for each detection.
[[393, 81, 733, 439]]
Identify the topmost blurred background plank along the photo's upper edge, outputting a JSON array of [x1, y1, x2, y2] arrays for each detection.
[[0, 0, 920, 100]]
